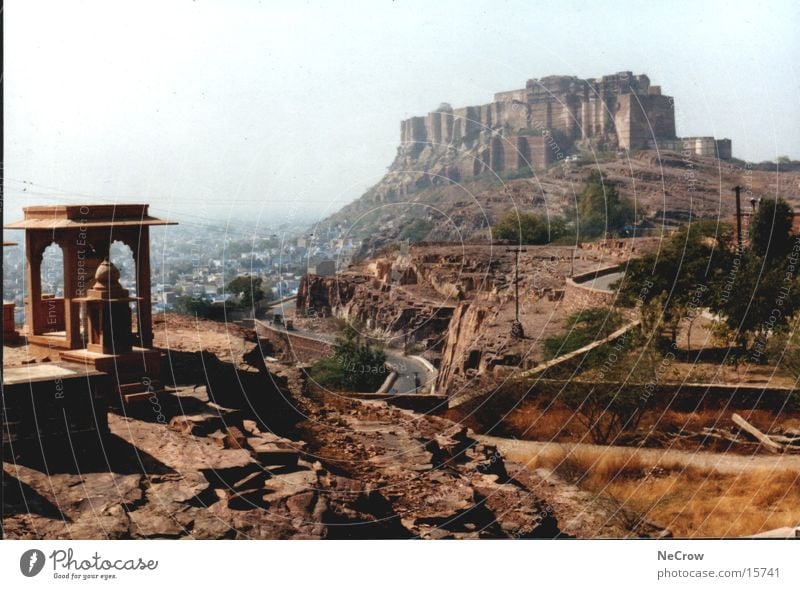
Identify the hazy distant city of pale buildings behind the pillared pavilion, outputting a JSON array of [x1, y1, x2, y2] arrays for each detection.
[[3, 219, 361, 325]]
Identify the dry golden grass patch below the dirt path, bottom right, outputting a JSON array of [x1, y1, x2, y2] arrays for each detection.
[[507, 446, 800, 538]]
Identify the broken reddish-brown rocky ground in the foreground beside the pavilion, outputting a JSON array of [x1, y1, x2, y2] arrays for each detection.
[[3, 317, 660, 538]]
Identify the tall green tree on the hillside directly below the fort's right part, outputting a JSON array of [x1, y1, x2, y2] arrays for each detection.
[[576, 170, 636, 239]]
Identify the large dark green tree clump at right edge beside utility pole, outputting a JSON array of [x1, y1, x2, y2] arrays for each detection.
[[619, 200, 800, 352]]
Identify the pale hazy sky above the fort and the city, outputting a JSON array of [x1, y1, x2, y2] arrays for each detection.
[[4, 0, 800, 224]]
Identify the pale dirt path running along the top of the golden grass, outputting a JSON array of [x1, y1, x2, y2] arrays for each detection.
[[475, 435, 800, 474]]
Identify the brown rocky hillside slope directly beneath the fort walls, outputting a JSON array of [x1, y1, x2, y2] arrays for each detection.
[[316, 150, 800, 253]]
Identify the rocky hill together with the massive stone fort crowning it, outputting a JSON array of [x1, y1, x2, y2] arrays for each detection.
[[316, 72, 800, 248]]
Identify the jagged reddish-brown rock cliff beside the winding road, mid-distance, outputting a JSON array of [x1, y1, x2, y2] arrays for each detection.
[[297, 244, 604, 395]]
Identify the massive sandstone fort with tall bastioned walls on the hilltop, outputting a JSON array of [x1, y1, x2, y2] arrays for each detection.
[[395, 72, 731, 191]]
